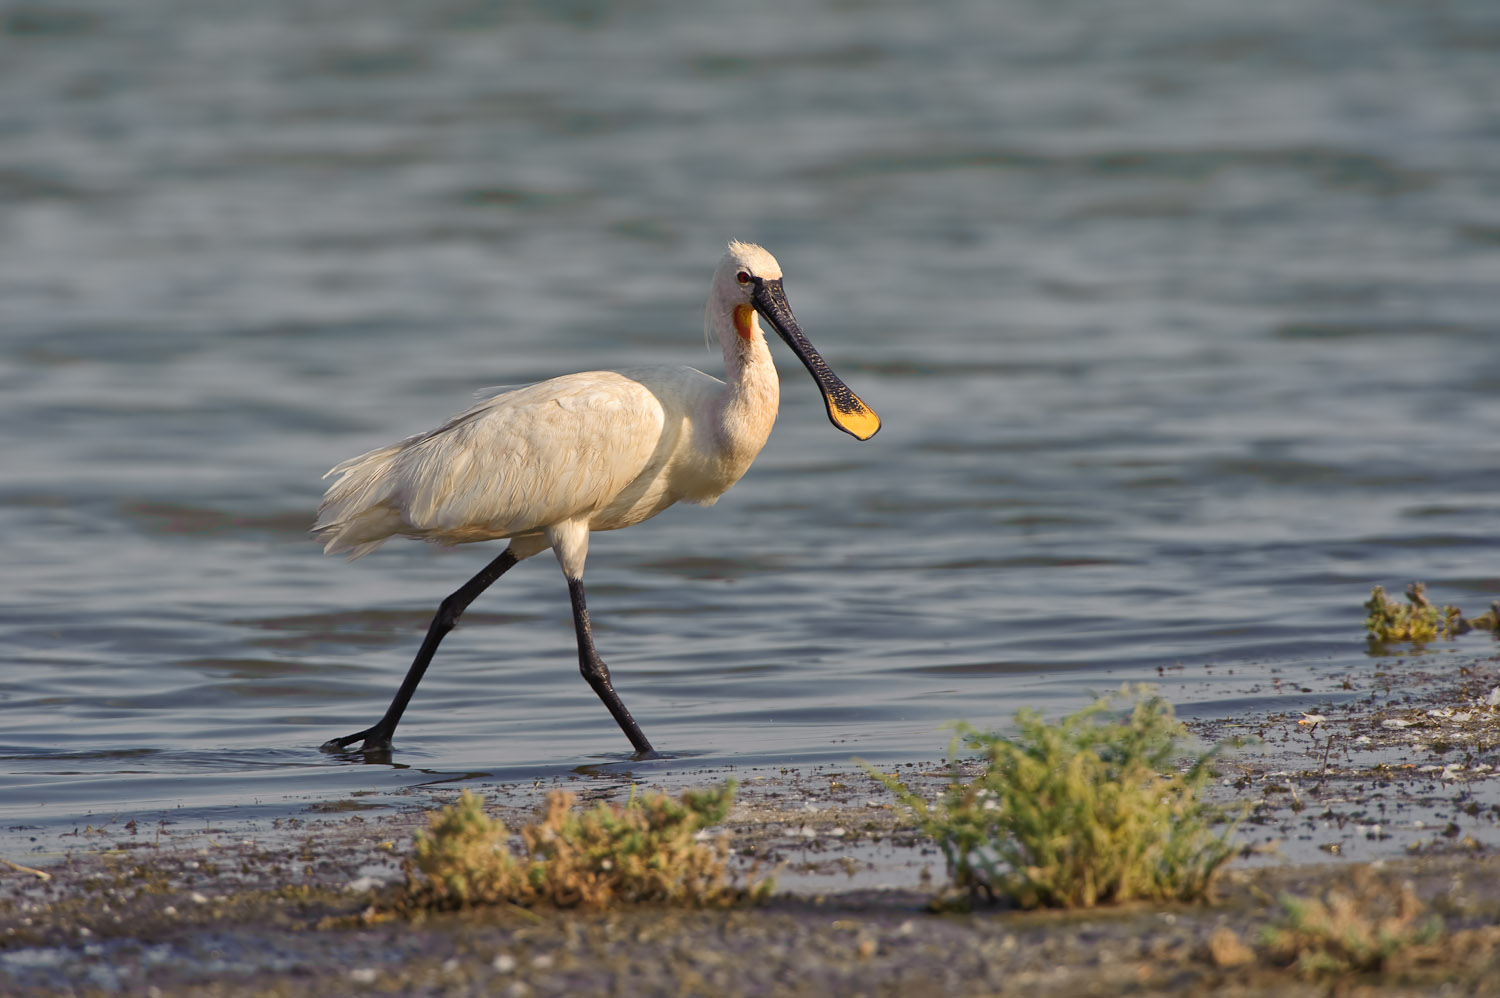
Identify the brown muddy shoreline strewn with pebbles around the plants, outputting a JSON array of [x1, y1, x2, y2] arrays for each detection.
[[0, 654, 1500, 998]]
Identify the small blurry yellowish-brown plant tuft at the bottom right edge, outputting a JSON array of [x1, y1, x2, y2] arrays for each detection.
[[1262, 882, 1443, 975]]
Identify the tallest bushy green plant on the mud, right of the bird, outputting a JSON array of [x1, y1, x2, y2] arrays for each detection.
[[866, 687, 1238, 908]]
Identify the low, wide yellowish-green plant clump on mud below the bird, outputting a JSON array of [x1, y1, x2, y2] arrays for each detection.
[[405, 782, 771, 909]]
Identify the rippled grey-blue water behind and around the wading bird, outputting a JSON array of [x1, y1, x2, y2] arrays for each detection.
[[0, 0, 1500, 833]]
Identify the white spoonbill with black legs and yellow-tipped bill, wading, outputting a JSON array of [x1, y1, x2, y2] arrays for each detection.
[[314, 242, 881, 756]]
